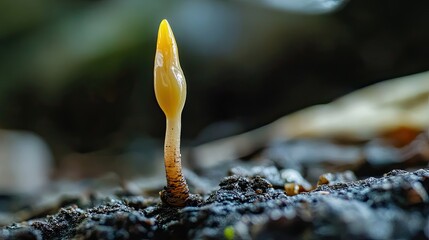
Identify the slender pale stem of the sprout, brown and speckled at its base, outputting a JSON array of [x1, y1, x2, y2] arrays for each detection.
[[161, 115, 189, 206]]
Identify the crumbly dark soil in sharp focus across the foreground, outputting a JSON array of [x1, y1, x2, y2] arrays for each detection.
[[0, 169, 429, 239]]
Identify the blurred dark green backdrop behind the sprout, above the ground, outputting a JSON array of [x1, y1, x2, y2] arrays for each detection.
[[0, 0, 429, 191]]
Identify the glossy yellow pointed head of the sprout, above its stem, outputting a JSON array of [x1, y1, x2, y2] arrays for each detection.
[[154, 19, 186, 119]]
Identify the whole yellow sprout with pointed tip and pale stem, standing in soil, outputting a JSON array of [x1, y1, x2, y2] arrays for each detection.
[[154, 19, 189, 207]]
